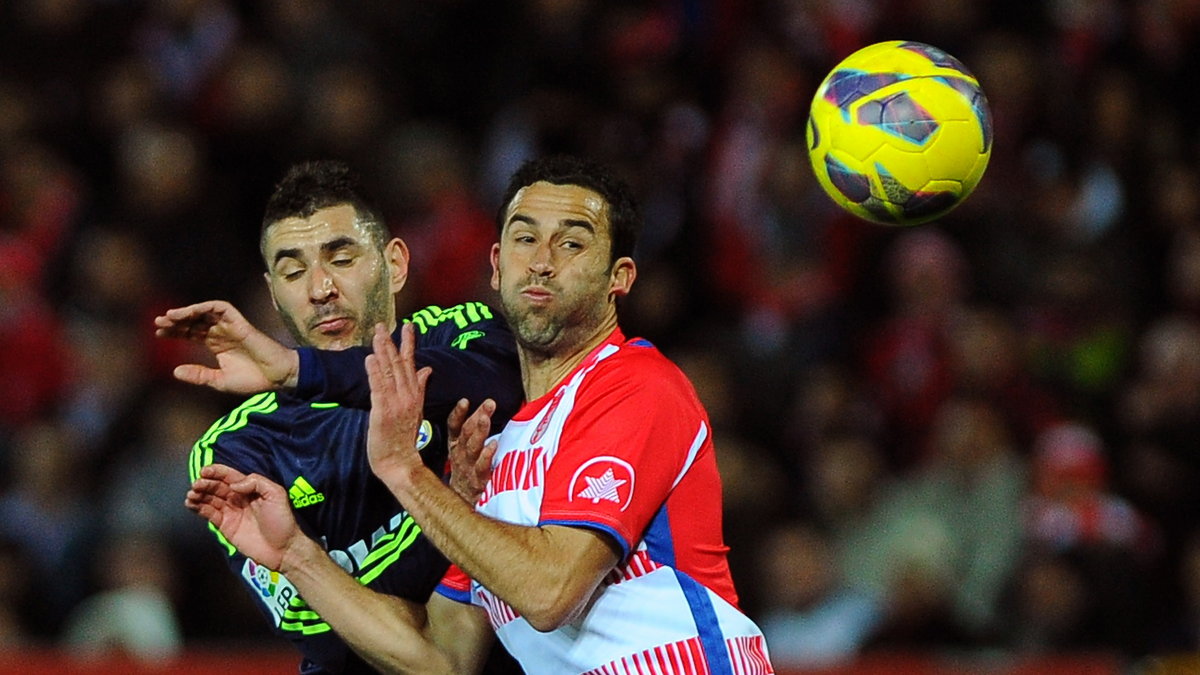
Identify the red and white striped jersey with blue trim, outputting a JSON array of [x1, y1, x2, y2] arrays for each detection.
[[439, 330, 774, 675]]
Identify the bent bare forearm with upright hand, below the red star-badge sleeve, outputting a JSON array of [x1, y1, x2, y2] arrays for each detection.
[[366, 325, 619, 631]]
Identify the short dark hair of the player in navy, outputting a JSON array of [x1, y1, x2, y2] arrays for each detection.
[[259, 160, 390, 255]]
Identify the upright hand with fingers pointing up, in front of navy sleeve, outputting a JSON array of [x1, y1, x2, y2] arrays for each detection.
[[366, 323, 432, 488]]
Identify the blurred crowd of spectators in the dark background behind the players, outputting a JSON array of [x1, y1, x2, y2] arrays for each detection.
[[0, 0, 1200, 664]]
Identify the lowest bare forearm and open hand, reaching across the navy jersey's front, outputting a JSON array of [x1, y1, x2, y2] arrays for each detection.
[[185, 464, 455, 674]]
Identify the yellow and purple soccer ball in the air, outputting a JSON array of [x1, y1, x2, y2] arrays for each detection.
[[806, 40, 991, 225]]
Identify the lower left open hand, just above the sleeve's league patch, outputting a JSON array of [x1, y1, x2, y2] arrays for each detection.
[[184, 464, 304, 571]]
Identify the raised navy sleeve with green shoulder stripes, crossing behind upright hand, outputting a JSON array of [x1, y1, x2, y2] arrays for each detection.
[[296, 303, 523, 420]]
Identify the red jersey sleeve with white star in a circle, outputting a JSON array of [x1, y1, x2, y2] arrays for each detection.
[[540, 363, 708, 556]]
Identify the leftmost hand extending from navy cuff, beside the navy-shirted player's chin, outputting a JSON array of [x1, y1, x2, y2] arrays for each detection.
[[154, 300, 300, 394]]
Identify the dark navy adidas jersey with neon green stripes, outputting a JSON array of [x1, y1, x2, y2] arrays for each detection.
[[188, 303, 522, 674]]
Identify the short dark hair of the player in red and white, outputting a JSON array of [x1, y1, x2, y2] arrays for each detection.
[[496, 155, 642, 263]]
